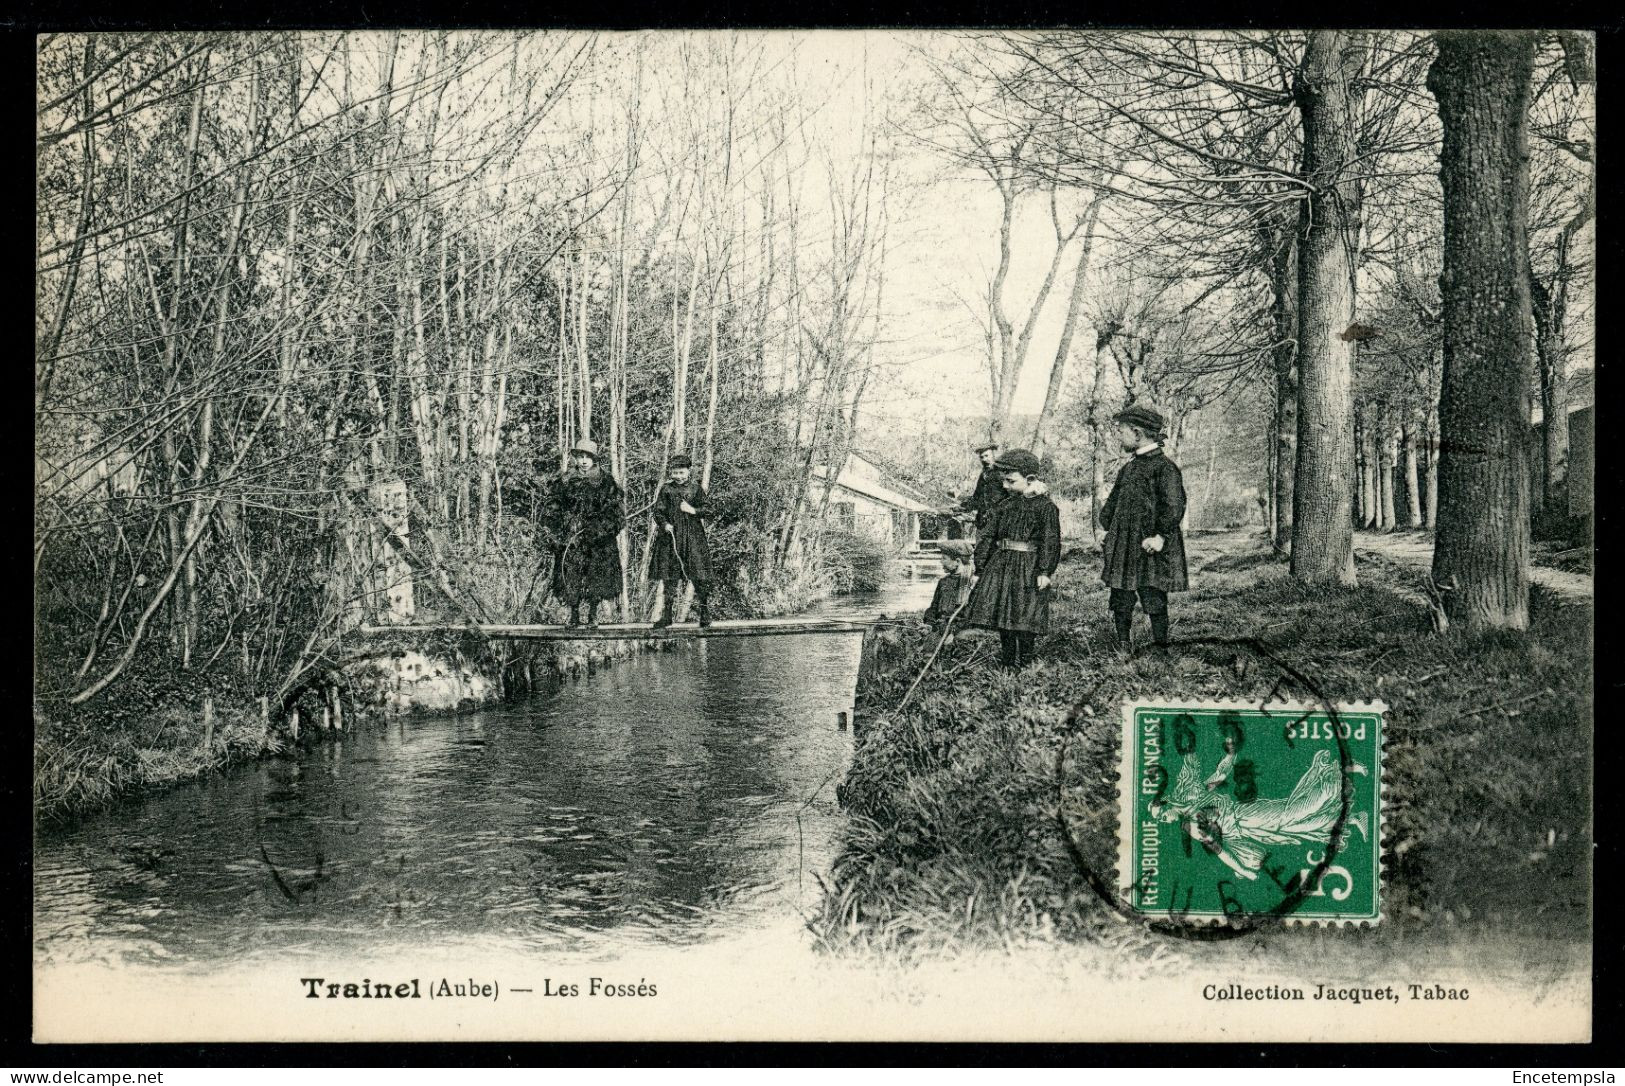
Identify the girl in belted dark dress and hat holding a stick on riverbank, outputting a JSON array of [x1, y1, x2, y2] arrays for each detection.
[[964, 449, 1061, 668]]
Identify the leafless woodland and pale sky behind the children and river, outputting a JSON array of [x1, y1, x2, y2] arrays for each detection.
[[34, 31, 1596, 747]]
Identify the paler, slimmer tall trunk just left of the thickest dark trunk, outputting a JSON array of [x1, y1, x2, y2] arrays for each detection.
[[1292, 31, 1360, 585]]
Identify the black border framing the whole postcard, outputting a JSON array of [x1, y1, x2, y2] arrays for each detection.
[[9, 0, 1625, 1081]]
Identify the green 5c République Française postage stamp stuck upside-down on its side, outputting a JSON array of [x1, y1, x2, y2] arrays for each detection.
[[1118, 699, 1388, 923]]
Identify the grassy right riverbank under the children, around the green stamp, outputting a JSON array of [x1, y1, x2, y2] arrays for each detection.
[[814, 533, 1593, 956]]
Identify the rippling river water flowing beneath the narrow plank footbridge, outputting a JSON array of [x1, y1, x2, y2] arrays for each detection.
[[34, 579, 933, 967]]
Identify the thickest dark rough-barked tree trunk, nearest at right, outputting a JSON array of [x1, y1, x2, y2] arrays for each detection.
[[1427, 31, 1536, 631]]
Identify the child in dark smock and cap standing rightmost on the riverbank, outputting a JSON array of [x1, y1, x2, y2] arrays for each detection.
[[1100, 405, 1190, 650]]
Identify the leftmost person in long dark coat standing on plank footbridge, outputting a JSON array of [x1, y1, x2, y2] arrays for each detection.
[[553, 439, 624, 629]]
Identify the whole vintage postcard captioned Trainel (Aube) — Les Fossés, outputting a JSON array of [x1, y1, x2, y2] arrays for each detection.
[[31, 28, 1596, 1044]]
